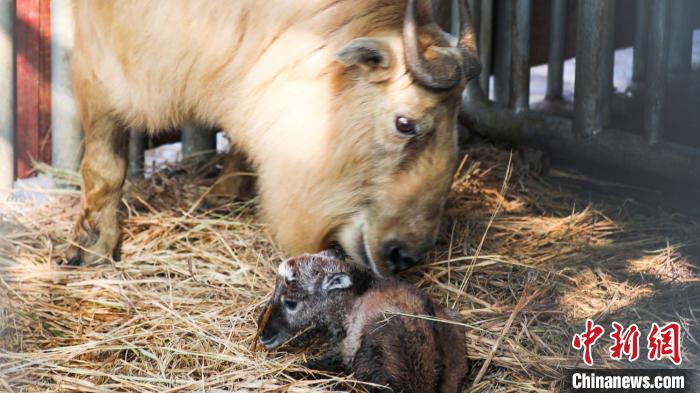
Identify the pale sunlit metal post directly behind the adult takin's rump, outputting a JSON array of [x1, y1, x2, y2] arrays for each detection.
[[51, 0, 83, 171]]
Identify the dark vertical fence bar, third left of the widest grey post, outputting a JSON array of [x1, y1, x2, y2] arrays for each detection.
[[493, 1, 513, 105]]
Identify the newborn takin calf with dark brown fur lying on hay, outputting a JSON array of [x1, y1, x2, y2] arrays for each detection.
[[260, 252, 468, 393]]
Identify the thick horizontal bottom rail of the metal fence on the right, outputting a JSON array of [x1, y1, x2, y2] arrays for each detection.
[[461, 89, 700, 184]]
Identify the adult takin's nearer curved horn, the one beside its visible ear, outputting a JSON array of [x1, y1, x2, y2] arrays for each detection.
[[403, 0, 462, 90]]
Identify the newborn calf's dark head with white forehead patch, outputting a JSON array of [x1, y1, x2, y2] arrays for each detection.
[[258, 252, 372, 349]]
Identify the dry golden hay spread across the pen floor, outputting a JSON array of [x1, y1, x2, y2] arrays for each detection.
[[0, 145, 700, 392]]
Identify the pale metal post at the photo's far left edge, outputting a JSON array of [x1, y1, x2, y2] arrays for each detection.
[[0, 0, 15, 201]]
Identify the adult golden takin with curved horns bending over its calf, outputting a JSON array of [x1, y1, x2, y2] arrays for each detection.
[[68, 0, 480, 275]]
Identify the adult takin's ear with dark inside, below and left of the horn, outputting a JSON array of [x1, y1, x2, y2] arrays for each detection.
[[335, 37, 394, 82]]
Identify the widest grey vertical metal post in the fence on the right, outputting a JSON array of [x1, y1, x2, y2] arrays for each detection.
[[573, 0, 615, 137]]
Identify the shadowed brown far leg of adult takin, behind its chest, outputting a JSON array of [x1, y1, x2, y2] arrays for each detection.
[[204, 146, 255, 207]]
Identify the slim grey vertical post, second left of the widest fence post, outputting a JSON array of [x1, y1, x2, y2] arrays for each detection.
[[509, 0, 532, 111]]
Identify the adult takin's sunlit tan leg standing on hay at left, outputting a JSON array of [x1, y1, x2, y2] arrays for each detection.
[[67, 116, 129, 266]]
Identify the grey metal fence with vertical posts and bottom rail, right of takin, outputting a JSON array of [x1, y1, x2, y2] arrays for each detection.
[[461, 0, 700, 188]]
